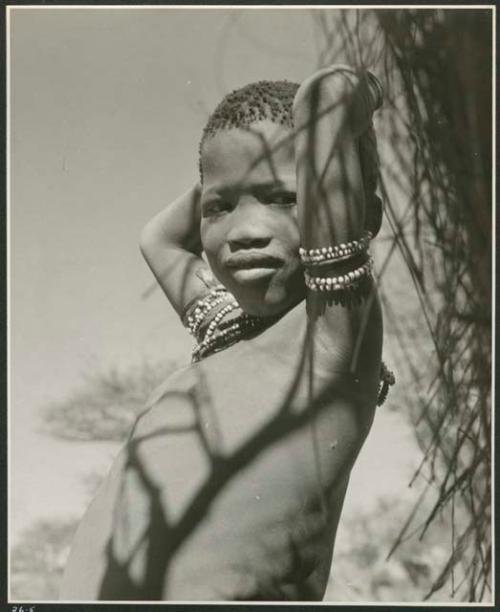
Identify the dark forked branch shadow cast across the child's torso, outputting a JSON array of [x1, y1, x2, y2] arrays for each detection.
[[98, 318, 372, 601]]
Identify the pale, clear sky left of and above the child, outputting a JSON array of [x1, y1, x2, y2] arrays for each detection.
[[9, 8, 426, 544]]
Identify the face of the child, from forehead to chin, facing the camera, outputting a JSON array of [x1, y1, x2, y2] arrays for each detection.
[[201, 121, 304, 316]]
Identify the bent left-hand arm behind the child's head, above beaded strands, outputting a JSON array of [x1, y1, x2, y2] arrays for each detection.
[[140, 184, 221, 317]]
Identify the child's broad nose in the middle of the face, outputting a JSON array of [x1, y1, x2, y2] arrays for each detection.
[[227, 201, 272, 251]]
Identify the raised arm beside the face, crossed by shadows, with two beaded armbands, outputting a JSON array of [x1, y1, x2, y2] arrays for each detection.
[[293, 66, 381, 354]]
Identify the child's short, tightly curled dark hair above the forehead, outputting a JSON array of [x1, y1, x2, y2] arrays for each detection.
[[198, 80, 379, 206]]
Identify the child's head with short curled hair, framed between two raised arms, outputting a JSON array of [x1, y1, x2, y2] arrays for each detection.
[[199, 81, 377, 316]]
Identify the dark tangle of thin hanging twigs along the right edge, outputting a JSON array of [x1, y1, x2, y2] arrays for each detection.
[[316, 9, 493, 601]]
